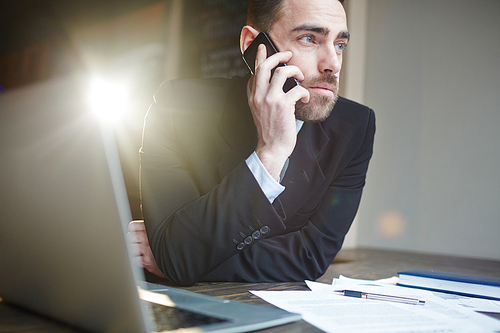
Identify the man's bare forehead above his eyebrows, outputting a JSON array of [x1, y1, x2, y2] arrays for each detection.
[[271, 0, 347, 34]]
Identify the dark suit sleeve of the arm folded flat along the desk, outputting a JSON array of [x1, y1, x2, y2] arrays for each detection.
[[203, 110, 375, 282]]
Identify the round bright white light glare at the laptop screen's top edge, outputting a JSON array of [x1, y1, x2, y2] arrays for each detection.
[[90, 78, 127, 124]]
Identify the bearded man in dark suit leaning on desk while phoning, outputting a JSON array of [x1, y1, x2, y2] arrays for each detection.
[[129, 0, 375, 285]]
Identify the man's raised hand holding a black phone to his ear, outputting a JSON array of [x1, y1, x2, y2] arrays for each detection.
[[243, 33, 309, 181]]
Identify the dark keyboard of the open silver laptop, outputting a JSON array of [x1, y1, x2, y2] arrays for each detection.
[[148, 302, 228, 331]]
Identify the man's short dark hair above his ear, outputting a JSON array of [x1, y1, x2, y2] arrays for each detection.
[[247, 0, 344, 32]]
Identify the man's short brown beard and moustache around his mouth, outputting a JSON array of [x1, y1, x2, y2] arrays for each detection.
[[295, 74, 339, 122]]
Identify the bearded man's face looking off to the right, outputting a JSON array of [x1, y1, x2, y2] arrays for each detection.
[[269, 0, 349, 121]]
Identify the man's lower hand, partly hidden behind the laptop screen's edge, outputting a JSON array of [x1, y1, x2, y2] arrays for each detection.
[[127, 221, 165, 278]]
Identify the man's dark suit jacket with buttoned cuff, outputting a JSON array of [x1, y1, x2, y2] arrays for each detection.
[[141, 78, 375, 285]]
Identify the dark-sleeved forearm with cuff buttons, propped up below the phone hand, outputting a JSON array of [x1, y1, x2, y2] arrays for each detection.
[[143, 158, 283, 285]]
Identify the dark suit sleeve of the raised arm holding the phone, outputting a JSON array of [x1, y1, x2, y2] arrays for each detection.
[[140, 79, 290, 285]]
